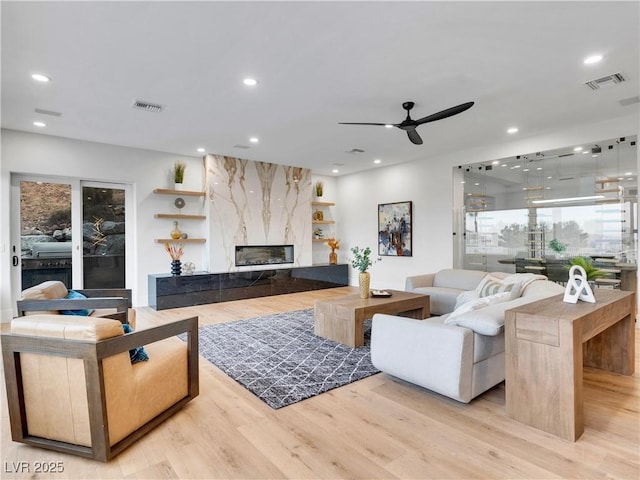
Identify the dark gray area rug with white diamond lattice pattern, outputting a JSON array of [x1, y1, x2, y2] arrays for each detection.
[[192, 308, 379, 408]]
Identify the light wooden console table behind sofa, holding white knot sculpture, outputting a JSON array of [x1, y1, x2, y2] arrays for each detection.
[[505, 289, 636, 441]]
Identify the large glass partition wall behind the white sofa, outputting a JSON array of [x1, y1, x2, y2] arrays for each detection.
[[454, 136, 638, 273]]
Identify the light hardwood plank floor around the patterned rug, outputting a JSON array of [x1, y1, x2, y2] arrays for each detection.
[[0, 287, 640, 479]]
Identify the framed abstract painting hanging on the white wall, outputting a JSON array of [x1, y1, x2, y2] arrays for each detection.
[[378, 202, 413, 257]]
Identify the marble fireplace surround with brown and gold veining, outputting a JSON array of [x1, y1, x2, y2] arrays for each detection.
[[204, 154, 313, 272]]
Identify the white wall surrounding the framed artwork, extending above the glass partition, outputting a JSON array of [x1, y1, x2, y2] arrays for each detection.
[[336, 115, 640, 290]]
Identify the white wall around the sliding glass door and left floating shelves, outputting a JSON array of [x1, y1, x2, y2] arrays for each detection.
[[0, 130, 204, 321]]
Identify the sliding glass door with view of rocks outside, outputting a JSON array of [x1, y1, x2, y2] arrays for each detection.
[[11, 175, 133, 306]]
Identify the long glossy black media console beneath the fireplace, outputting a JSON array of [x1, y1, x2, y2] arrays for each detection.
[[148, 264, 349, 310]]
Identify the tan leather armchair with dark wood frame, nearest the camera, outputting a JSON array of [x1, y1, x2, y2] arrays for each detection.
[[2, 315, 199, 461]]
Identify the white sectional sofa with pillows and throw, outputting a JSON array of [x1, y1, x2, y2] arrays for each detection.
[[371, 269, 564, 403]]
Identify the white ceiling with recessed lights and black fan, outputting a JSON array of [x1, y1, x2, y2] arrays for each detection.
[[2, 1, 640, 174]]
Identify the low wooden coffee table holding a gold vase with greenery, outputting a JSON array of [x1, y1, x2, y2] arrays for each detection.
[[314, 290, 429, 348]]
